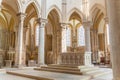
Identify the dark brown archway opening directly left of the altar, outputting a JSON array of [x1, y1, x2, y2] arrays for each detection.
[[45, 9, 61, 64]]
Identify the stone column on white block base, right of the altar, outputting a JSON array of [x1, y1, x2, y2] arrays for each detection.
[[83, 21, 92, 66]]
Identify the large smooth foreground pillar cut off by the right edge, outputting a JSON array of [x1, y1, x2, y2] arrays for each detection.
[[107, 0, 120, 80]]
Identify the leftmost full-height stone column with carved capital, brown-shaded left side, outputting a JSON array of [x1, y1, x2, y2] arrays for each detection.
[[15, 13, 26, 68]]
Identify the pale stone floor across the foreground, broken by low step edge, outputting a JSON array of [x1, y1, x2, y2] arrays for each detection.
[[0, 68, 112, 80]]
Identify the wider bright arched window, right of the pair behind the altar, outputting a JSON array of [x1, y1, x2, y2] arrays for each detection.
[[77, 26, 85, 46]]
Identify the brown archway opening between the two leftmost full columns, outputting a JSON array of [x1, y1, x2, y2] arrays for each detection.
[[24, 2, 39, 66]]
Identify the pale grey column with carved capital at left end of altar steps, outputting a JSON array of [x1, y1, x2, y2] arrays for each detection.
[[38, 18, 47, 66]]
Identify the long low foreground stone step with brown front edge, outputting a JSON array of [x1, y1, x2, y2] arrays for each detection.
[[7, 69, 91, 80]]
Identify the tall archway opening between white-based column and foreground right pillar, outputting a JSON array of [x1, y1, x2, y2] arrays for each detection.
[[91, 6, 110, 64]]
